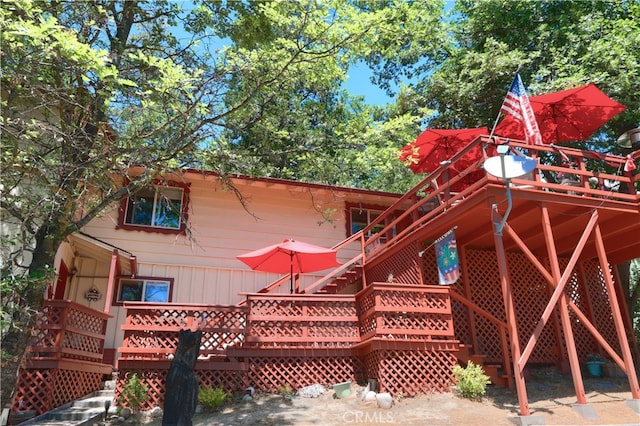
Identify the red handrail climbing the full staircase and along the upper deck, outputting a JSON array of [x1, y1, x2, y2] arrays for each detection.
[[239, 136, 640, 298]]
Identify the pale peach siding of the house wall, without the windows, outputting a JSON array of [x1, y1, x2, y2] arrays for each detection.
[[70, 174, 395, 354]]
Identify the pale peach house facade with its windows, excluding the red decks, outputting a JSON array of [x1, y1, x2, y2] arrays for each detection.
[[53, 170, 400, 364]]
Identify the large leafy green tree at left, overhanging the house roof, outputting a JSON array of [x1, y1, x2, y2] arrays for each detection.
[[0, 0, 448, 406]]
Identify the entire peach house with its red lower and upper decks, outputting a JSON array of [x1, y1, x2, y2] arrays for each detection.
[[10, 136, 640, 422]]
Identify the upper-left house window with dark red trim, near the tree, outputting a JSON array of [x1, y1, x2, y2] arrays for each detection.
[[118, 184, 188, 233]]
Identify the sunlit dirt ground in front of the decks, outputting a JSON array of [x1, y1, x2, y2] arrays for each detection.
[[145, 369, 640, 426]]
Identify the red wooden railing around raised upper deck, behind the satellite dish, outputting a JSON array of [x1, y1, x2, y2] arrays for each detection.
[[361, 136, 640, 263]]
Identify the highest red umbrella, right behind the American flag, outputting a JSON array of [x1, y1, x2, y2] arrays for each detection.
[[494, 83, 626, 144]]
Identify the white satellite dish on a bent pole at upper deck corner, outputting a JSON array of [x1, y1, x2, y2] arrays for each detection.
[[484, 144, 538, 235]]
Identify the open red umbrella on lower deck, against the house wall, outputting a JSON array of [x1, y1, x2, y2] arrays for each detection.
[[237, 239, 340, 293]]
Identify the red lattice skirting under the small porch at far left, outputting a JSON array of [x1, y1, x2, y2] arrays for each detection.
[[12, 368, 103, 414]]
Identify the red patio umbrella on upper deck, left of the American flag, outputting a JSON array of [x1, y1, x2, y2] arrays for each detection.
[[400, 127, 489, 191]]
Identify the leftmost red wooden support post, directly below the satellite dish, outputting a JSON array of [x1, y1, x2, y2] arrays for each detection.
[[492, 204, 530, 416]]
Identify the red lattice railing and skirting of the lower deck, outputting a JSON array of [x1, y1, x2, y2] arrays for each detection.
[[118, 283, 457, 406]]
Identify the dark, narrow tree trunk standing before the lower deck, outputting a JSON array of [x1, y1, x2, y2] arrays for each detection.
[[162, 330, 202, 426]]
